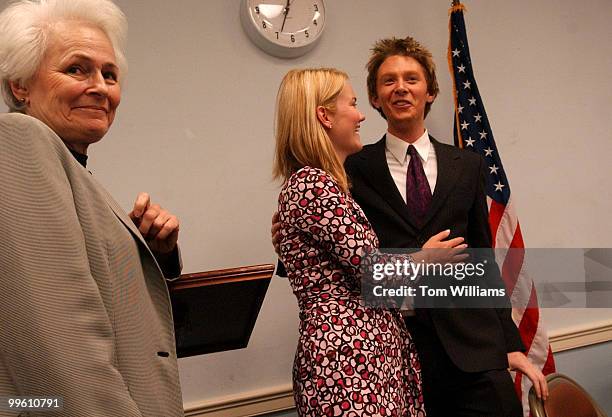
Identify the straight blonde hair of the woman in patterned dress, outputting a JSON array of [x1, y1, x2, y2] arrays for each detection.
[[273, 68, 348, 192]]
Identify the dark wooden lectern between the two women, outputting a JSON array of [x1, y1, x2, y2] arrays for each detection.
[[168, 265, 274, 358]]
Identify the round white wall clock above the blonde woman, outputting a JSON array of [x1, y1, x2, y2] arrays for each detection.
[[242, 0, 325, 57]]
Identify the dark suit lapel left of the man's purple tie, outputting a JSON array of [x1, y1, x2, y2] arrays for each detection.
[[361, 135, 418, 228]]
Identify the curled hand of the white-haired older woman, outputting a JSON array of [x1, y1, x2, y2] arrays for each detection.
[[129, 193, 179, 254]]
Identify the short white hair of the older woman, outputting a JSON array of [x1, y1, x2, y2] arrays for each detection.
[[0, 0, 127, 112]]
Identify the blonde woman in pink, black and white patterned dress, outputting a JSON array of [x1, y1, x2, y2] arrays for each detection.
[[274, 69, 425, 416]]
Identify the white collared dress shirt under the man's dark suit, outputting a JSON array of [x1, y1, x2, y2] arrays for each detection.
[[385, 129, 438, 201]]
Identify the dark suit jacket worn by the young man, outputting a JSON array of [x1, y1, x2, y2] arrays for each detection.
[[345, 136, 523, 372]]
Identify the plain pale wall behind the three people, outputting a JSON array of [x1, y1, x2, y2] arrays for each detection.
[[0, 0, 612, 403]]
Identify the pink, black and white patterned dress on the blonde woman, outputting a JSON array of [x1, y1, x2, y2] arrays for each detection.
[[279, 167, 425, 417]]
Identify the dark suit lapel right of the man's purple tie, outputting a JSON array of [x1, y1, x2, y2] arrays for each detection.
[[422, 136, 461, 226]]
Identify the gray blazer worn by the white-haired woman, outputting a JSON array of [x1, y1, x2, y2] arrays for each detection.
[[0, 114, 183, 417]]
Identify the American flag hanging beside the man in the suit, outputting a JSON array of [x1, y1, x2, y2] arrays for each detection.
[[448, 1, 555, 416]]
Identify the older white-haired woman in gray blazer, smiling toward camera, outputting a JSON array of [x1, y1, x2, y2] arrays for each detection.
[[0, 0, 183, 417]]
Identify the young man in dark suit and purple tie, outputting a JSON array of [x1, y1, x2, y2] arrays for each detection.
[[345, 37, 546, 417]]
